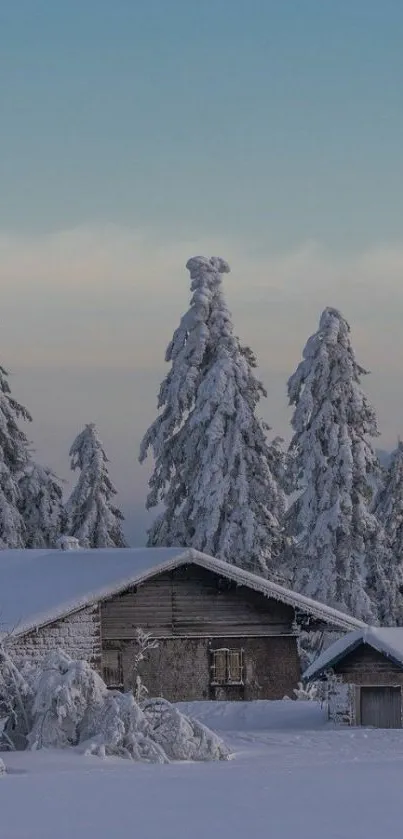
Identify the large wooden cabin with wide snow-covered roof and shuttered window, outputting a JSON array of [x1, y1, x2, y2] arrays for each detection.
[[0, 548, 364, 701]]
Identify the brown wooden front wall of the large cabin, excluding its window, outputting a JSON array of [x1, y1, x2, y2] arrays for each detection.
[[101, 565, 300, 702]]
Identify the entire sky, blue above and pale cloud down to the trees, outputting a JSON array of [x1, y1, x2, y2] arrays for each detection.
[[0, 0, 403, 544]]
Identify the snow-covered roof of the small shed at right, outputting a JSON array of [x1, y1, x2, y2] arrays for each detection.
[[303, 626, 403, 681]]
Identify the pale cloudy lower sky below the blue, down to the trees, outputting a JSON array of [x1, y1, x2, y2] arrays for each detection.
[[0, 225, 403, 532]]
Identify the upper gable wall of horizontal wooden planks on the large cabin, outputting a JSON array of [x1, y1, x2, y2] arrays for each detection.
[[101, 565, 294, 641]]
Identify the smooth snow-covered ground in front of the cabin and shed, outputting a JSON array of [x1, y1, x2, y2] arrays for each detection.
[[0, 702, 403, 839]]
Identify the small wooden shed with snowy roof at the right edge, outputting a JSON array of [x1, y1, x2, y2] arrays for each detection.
[[303, 627, 403, 728]]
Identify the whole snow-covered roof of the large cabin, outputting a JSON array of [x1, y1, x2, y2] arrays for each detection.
[[0, 548, 364, 635]]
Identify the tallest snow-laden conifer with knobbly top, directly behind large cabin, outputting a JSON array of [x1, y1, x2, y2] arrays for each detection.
[[140, 257, 284, 574]]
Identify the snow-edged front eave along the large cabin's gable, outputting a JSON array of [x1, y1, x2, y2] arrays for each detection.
[[0, 548, 366, 638]]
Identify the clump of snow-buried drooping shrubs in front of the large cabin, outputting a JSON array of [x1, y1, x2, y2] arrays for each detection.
[[28, 652, 228, 763]]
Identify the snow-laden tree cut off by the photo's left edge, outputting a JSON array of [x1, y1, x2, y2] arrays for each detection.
[[0, 366, 31, 549]]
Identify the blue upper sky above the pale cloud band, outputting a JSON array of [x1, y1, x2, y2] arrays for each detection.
[[0, 0, 403, 248]]
